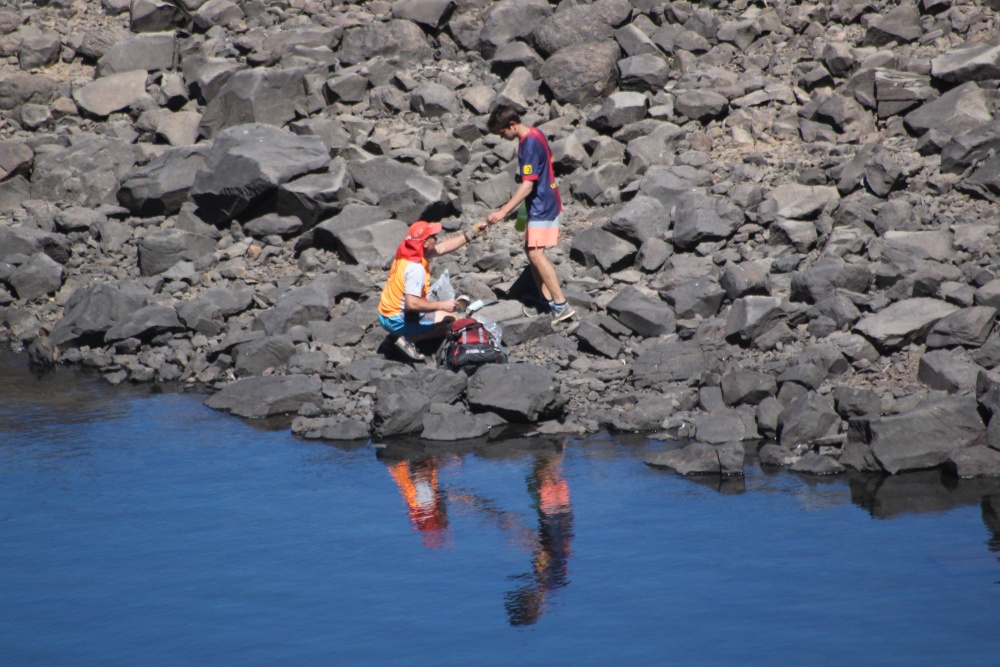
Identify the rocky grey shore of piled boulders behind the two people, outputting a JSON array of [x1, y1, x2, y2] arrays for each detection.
[[9, 0, 1000, 477]]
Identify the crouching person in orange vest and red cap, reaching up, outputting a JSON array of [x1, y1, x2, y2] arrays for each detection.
[[378, 220, 479, 361]]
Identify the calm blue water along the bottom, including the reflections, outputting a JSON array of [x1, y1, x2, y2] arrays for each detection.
[[0, 355, 1000, 666]]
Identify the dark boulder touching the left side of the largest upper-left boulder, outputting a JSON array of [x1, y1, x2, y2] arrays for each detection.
[[117, 145, 208, 217]]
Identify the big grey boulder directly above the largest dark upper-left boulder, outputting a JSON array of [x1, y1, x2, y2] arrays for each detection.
[[199, 68, 306, 139]]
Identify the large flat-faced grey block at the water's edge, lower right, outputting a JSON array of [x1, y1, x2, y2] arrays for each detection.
[[859, 396, 986, 475]]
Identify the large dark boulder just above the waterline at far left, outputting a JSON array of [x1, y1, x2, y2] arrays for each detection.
[[49, 283, 146, 345]]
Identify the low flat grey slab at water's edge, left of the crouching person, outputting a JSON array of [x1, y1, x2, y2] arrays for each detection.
[[205, 375, 323, 418]]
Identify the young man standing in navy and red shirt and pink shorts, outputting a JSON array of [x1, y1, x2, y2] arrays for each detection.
[[486, 104, 576, 322]]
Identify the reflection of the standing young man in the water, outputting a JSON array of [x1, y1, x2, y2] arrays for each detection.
[[504, 456, 573, 625]]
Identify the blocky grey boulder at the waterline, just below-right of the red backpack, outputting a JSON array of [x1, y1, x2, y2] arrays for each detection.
[[468, 364, 566, 422]]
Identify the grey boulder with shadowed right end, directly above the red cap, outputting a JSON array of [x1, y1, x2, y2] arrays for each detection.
[[350, 157, 453, 224]]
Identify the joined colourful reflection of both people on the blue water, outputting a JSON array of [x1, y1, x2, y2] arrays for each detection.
[[387, 444, 573, 626]]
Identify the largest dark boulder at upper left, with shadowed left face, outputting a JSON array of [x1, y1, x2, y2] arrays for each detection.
[[191, 123, 330, 223]]
